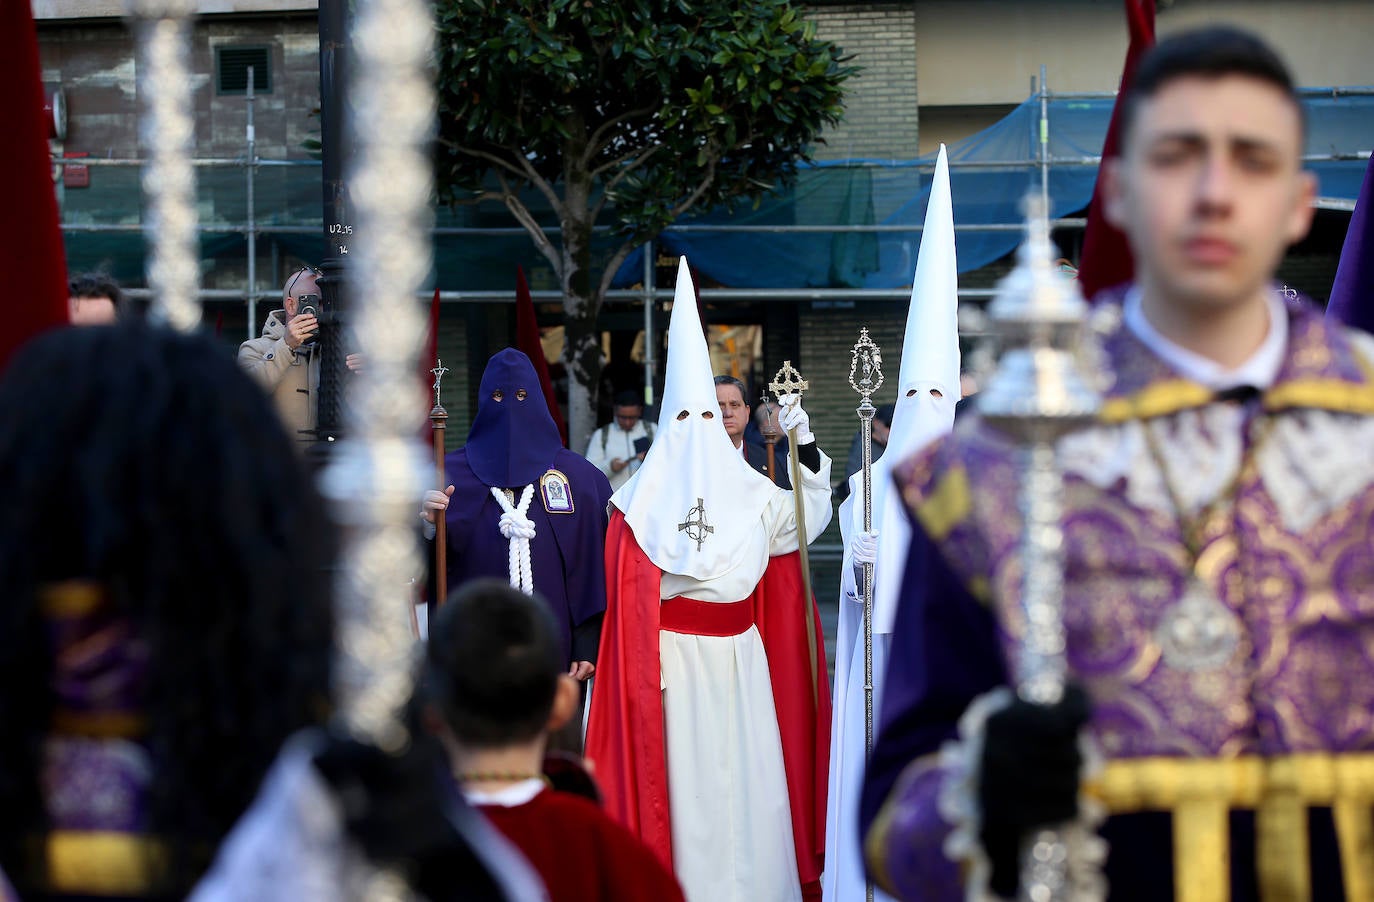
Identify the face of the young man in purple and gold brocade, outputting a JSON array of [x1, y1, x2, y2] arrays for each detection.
[[1103, 76, 1315, 312]]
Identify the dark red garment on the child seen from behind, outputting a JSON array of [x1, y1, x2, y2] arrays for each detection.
[[477, 789, 683, 902]]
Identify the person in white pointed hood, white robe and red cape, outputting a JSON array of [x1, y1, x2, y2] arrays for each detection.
[[587, 259, 831, 902]]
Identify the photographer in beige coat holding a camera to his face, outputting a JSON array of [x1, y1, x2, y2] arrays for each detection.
[[238, 267, 361, 441]]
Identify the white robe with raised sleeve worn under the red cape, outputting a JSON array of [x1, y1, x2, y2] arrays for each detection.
[[660, 454, 831, 902]]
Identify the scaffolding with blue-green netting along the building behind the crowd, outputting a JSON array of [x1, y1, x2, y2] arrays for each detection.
[[54, 78, 1374, 345]]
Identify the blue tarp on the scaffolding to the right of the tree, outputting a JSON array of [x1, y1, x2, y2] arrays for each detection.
[[617, 88, 1374, 289]]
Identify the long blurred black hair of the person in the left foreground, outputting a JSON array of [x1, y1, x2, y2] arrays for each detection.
[[0, 323, 334, 897]]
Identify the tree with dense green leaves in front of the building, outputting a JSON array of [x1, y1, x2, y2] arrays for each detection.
[[436, 0, 856, 448]]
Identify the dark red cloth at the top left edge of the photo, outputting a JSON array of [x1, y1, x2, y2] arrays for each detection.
[[0, 0, 67, 370]]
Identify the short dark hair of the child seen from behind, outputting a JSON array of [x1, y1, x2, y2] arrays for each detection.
[[425, 579, 563, 748]]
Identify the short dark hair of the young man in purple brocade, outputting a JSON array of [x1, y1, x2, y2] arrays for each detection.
[[1121, 25, 1307, 149]]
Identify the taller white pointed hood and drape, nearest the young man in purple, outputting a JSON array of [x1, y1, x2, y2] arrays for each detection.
[[840, 144, 960, 633]]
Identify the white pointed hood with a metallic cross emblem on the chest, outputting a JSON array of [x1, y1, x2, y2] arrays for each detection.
[[610, 257, 779, 580]]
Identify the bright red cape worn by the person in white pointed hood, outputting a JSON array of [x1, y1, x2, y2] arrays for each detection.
[[587, 510, 830, 898]]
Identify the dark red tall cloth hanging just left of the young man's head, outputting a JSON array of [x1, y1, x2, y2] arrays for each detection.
[[1079, 0, 1154, 298]]
